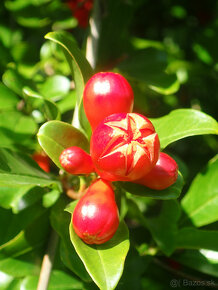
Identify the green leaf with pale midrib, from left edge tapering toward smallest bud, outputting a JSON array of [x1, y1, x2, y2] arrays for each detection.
[[0, 148, 60, 188]]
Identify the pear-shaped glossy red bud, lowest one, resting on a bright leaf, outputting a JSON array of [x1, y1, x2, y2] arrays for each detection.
[[72, 179, 119, 244]]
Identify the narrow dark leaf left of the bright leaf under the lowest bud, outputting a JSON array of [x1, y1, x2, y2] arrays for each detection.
[[50, 196, 91, 282]]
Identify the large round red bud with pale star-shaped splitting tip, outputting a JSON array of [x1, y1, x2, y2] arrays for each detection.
[[90, 113, 160, 181]]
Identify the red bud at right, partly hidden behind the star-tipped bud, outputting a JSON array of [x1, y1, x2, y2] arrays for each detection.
[[134, 152, 178, 190]]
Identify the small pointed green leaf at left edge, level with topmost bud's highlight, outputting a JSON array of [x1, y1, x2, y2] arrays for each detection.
[[0, 82, 19, 111]]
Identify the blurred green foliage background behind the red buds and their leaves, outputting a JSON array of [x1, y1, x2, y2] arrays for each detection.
[[0, 0, 218, 290]]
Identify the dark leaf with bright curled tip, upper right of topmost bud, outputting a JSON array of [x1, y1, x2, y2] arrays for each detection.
[[118, 47, 180, 95]]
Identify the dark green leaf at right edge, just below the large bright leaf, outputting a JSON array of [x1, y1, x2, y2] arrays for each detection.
[[176, 227, 218, 251]]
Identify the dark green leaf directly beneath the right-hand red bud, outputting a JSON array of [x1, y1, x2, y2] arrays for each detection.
[[119, 173, 183, 200]]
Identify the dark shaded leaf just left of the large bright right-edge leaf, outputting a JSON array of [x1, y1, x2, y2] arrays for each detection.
[[147, 200, 181, 256]]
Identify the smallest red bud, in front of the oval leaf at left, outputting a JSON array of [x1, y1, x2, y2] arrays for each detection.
[[59, 146, 94, 175]]
